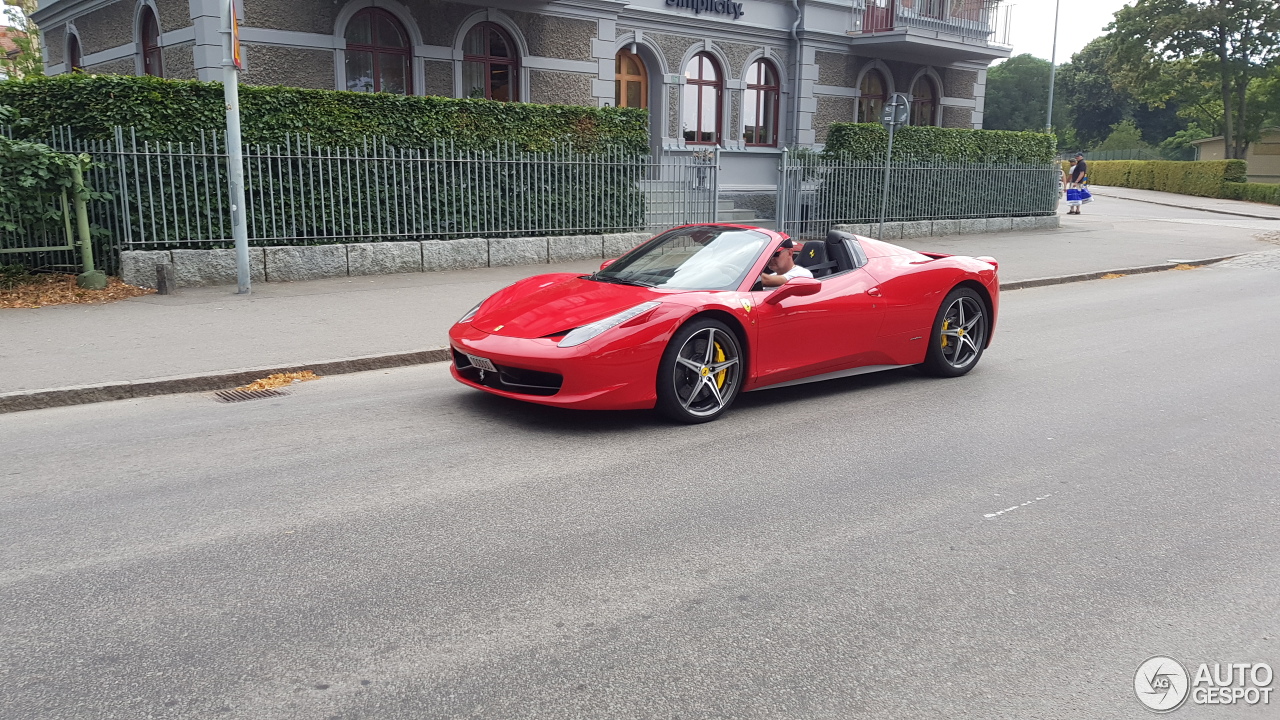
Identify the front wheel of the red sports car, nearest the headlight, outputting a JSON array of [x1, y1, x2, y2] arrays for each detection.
[[658, 318, 746, 424]]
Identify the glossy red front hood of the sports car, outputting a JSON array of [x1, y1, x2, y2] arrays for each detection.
[[471, 273, 669, 337]]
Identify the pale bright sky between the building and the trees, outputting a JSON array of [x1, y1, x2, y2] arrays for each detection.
[[1006, 0, 1133, 63]]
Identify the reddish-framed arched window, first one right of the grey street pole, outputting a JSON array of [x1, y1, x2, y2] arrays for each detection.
[[346, 8, 413, 95]]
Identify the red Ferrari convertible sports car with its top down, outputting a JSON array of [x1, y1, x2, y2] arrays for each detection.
[[449, 224, 1000, 423]]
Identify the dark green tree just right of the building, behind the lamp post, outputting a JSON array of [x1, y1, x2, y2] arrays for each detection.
[[982, 54, 1066, 131]]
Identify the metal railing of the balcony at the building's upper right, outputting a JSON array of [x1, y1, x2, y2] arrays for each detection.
[[861, 0, 1012, 46]]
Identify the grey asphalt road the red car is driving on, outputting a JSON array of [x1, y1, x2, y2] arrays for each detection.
[[0, 254, 1280, 720]]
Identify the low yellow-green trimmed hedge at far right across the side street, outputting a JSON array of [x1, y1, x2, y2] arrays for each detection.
[[1062, 160, 1248, 197]]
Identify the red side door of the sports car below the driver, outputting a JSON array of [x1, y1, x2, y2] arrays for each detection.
[[751, 268, 884, 387]]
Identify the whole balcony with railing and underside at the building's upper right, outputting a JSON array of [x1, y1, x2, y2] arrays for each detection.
[[849, 0, 1012, 64]]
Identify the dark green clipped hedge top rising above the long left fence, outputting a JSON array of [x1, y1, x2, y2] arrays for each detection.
[[0, 73, 649, 154]]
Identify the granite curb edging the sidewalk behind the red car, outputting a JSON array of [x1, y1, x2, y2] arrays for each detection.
[[0, 255, 1239, 414]]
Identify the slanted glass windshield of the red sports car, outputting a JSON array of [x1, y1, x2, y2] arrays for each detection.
[[591, 225, 769, 290]]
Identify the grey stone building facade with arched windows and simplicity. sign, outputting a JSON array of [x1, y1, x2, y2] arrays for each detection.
[[35, 0, 1009, 191]]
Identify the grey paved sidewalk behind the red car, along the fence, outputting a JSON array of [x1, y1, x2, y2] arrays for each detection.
[[0, 193, 1280, 393]]
